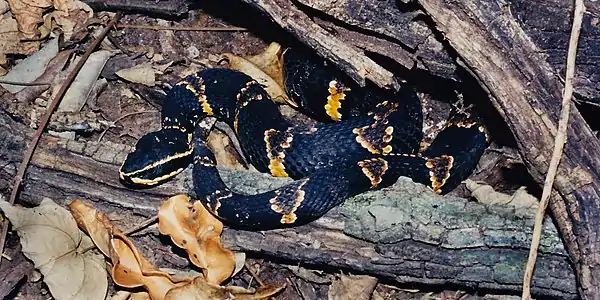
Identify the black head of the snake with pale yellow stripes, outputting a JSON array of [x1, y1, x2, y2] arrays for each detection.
[[119, 128, 194, 186]]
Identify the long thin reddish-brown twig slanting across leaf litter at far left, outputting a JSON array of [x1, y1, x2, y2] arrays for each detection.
[[0, 13, 121, 263]]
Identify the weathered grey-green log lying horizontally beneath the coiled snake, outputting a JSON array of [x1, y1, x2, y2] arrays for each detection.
[[0, 94, 577, 299]]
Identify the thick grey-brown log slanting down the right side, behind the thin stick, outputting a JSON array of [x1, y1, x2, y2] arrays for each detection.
[[420, 0, 600, 299]]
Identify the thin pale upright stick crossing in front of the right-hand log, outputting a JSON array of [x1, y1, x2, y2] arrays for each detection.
[[522, 0, 585, 300]]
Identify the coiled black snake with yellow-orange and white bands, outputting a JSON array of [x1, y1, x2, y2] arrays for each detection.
[[119, 48, 488, 231]]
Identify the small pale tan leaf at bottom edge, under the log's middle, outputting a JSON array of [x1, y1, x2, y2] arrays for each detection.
[[327, 275, 377, 300]]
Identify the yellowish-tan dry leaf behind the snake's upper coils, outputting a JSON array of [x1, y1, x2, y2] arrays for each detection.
[[222, 43, 298, 107]]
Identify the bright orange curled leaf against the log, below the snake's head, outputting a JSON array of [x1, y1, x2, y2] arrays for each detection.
[[158, 195, 236, 284]]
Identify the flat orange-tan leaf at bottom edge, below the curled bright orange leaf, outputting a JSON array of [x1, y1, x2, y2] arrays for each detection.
[[165, 276, 285, 300]]
